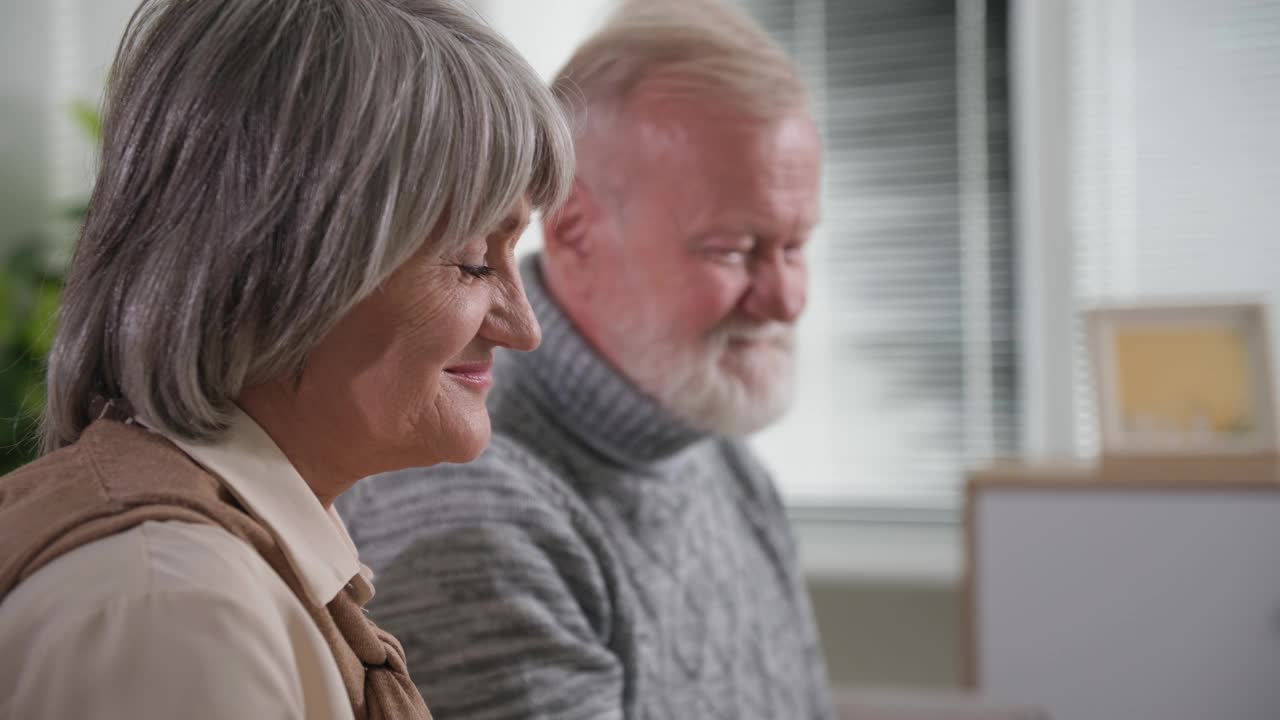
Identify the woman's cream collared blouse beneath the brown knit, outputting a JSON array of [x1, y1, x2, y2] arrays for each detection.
[[0, 413, 370, 720]]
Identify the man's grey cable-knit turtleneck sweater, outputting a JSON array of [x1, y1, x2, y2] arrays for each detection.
[[339, 258, 832, 720]]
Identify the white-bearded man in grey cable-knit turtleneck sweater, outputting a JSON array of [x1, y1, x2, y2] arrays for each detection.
[[342, 0, 831, 720]]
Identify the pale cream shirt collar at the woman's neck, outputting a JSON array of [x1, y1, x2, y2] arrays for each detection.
[[169, 407, 372, 606]]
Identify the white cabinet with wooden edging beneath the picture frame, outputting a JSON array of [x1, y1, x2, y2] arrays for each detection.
[[966, 461, 1280, 720]]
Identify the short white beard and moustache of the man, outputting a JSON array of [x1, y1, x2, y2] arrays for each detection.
[[618, 313, 795, 436]]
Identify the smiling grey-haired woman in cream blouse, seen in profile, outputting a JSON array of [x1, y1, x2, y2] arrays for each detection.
[[0, 0, 572, 720]]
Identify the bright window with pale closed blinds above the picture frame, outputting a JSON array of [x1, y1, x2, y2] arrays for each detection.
[[1069, 0, 1280, 455]]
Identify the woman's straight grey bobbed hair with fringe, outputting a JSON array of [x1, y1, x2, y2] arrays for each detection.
[[44, 0, 573, 452]]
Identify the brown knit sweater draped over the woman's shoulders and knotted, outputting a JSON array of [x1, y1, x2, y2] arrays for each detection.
[[0, 420, 430, 720]]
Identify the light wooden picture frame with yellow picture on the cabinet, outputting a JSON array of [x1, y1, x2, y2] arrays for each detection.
[[1085, 302, 1277, 456]]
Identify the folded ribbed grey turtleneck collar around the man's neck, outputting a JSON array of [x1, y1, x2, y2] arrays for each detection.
[[494, 254, 709, 466]]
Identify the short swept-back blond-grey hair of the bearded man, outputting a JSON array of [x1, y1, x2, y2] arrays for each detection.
[[553, 0, 809, 140]]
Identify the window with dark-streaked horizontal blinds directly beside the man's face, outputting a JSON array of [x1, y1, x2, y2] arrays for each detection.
[[739, 0, 1019, 512]]
